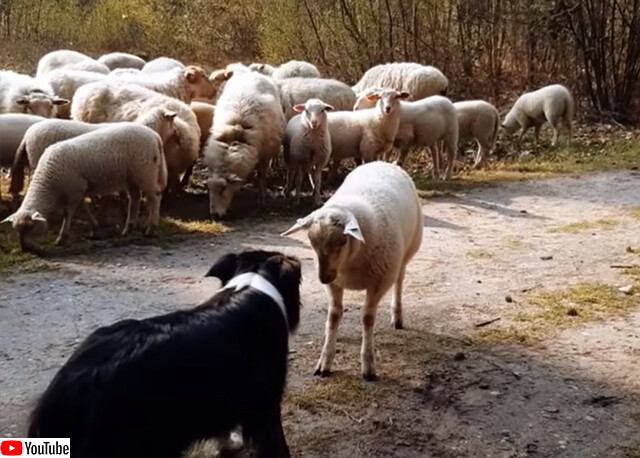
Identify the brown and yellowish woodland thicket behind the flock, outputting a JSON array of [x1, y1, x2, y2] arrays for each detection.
[[0, 0, 640, 124]]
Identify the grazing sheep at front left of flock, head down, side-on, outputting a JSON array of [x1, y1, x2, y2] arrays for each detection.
[[2, 123, 167, 251]]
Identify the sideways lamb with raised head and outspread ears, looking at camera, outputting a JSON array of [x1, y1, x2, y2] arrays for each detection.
[[328, 89, 410, 176]]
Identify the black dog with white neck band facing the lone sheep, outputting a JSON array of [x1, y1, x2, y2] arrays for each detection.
[[29, 251, 301, 458]]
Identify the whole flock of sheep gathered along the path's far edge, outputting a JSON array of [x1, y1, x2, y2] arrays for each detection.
[[0, 50, 574, 254]]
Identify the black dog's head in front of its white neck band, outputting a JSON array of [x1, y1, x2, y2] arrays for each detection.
[[205, 250, 302, 332]]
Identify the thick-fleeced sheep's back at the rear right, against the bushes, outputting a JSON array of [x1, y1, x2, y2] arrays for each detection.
[[353, 62, 449, 100]]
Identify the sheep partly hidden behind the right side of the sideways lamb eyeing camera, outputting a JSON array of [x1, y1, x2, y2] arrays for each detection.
[[354, 87, 459, 179]]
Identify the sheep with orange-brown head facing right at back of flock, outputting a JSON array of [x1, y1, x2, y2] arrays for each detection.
[[109, 65, 216, 103]]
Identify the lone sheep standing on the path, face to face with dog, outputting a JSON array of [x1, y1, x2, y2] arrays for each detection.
[[283, 162, 423, 380]]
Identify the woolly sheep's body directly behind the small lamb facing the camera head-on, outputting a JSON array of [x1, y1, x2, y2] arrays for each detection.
[[275, 78, 356, 121]]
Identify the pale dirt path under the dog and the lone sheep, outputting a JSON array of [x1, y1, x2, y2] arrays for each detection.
[[0, 172, 640, 458]]
